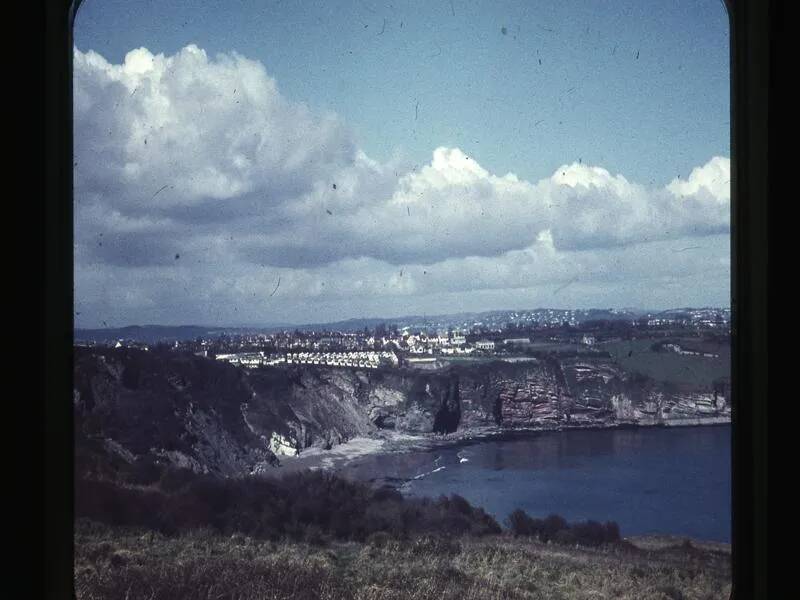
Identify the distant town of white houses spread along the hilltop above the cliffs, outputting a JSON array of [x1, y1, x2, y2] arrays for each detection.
[[76, 308, 730, 369]]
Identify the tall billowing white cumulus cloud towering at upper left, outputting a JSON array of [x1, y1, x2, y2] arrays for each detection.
[[74, 45, 356, 213]]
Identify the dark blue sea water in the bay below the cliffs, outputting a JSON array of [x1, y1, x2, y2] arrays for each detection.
[[338, 426, 731, 542]]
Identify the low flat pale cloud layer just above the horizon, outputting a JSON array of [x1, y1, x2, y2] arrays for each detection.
[[76, 234, 730, 325]]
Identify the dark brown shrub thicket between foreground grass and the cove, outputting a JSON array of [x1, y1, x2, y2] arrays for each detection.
[[75, 468, 501, 543]]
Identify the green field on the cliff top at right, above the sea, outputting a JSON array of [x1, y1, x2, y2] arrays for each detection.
[[596, 339, 731, 387]]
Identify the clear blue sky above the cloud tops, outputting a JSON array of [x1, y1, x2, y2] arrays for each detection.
[[75, 0, 730, 183]]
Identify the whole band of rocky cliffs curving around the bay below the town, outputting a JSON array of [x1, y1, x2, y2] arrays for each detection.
[[73, 349, 730, 475]]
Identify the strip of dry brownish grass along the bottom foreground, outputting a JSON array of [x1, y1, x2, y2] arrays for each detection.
[[75, 521, 731, 600]]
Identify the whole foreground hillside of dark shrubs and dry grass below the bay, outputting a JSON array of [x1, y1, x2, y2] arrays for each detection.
[[74, 469, 730, 600]]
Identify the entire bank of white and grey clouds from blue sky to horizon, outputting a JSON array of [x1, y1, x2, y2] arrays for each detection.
[[74, 45, 730, 321]]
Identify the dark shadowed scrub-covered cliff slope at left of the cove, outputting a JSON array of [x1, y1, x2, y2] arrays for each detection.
[[73, 351, 283, 475]]
